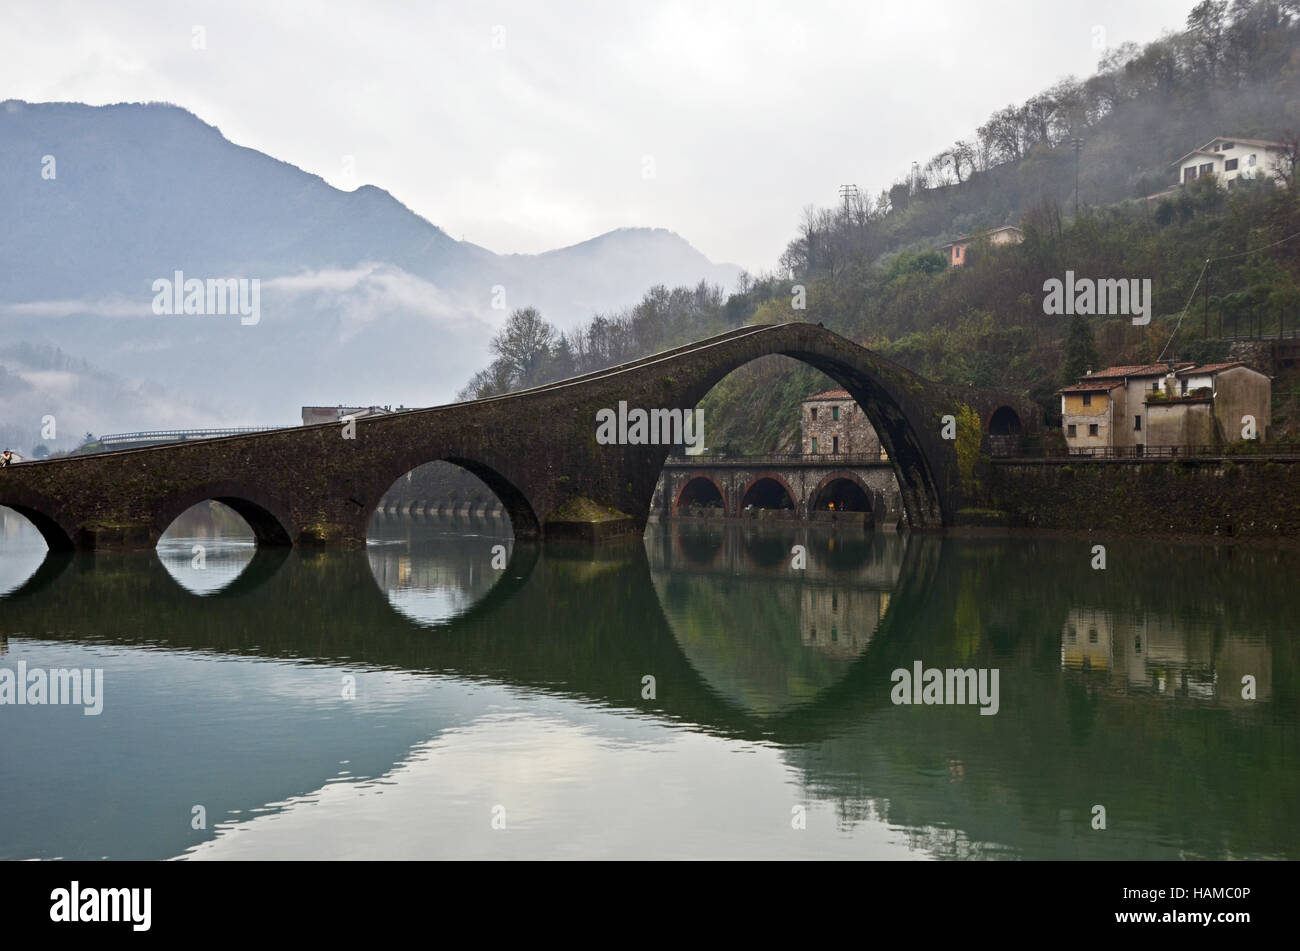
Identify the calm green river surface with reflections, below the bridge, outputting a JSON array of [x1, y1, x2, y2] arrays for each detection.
[[0, 509, 1300, 860]]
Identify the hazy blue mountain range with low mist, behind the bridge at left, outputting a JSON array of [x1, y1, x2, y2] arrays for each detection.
[[0, 100, 738, 433]]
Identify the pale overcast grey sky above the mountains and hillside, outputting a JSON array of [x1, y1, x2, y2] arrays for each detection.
[[0, 0, 1193, 270]]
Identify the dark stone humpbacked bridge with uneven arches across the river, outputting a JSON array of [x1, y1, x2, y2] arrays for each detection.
[[0, 322, 1032, 550]]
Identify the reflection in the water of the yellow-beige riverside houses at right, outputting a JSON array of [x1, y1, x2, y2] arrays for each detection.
[[1061, 608, 1273, 704]]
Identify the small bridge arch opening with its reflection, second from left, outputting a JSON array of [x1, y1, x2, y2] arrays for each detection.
[[157, 499, 258, 595]]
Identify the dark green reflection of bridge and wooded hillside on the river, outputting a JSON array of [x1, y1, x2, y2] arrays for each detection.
[[3, 519, 1300, 857]]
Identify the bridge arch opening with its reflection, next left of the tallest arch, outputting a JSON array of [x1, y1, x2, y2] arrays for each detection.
[[365, 460, 536, 628]]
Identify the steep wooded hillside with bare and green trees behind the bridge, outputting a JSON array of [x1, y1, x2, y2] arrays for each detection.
[[460, 0, 1300, 452]]
